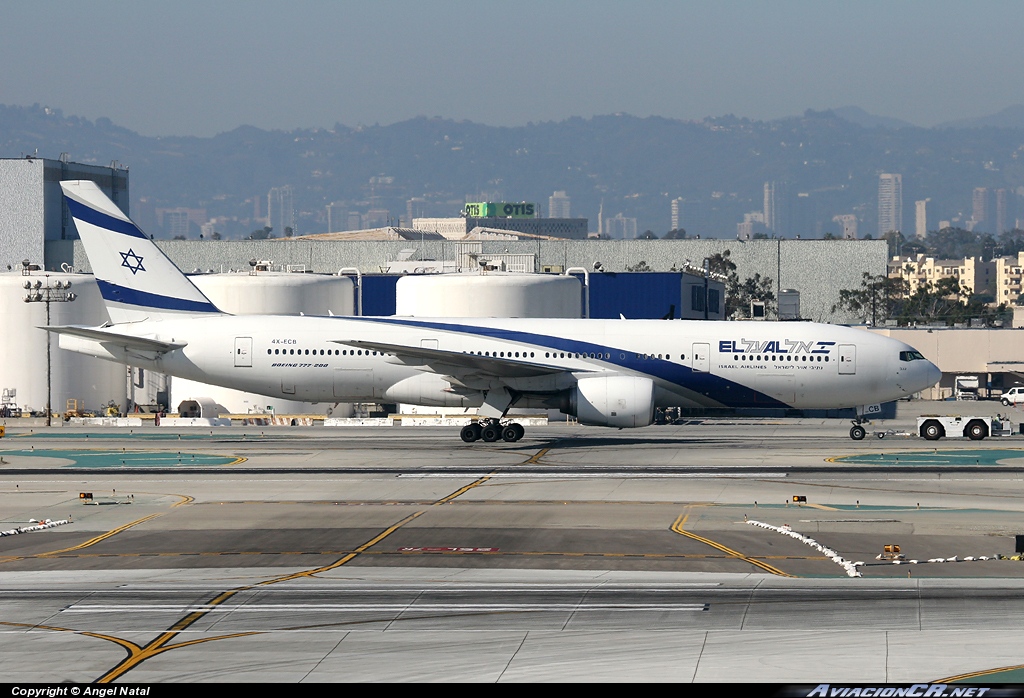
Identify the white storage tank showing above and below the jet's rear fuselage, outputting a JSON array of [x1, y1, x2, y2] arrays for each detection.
[[170, 271, 355, 417]]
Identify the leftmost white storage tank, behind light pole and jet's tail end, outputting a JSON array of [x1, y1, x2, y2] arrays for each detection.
[[0, 271, 128, 413]]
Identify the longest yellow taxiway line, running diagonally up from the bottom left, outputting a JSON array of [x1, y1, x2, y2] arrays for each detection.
[[96, 466, 492, 684]]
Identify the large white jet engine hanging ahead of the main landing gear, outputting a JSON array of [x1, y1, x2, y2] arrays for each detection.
[[562, 376, 654, 428]]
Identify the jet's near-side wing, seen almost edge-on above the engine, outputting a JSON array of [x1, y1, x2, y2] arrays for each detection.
[[333, 340, 579, 378]]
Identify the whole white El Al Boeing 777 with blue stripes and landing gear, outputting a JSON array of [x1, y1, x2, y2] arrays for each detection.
[[46, 181, 940, 443]]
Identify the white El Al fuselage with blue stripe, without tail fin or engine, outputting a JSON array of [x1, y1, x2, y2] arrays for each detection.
[[60, 315, 939, 408]]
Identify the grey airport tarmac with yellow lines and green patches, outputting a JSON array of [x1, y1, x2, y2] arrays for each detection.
[[0, 413, 1024, 684]]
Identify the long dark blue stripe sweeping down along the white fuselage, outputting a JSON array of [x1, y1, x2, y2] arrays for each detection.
[[344, 317, 790, 407]]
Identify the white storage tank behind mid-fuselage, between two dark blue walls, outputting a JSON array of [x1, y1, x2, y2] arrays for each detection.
[[395, 272, 583, 317]]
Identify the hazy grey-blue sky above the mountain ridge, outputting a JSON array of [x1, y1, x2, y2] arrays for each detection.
[[0, 0, 1024, 136]]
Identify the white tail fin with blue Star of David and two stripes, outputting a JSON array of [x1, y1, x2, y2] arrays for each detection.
[[60, 180, 221, 322]]
